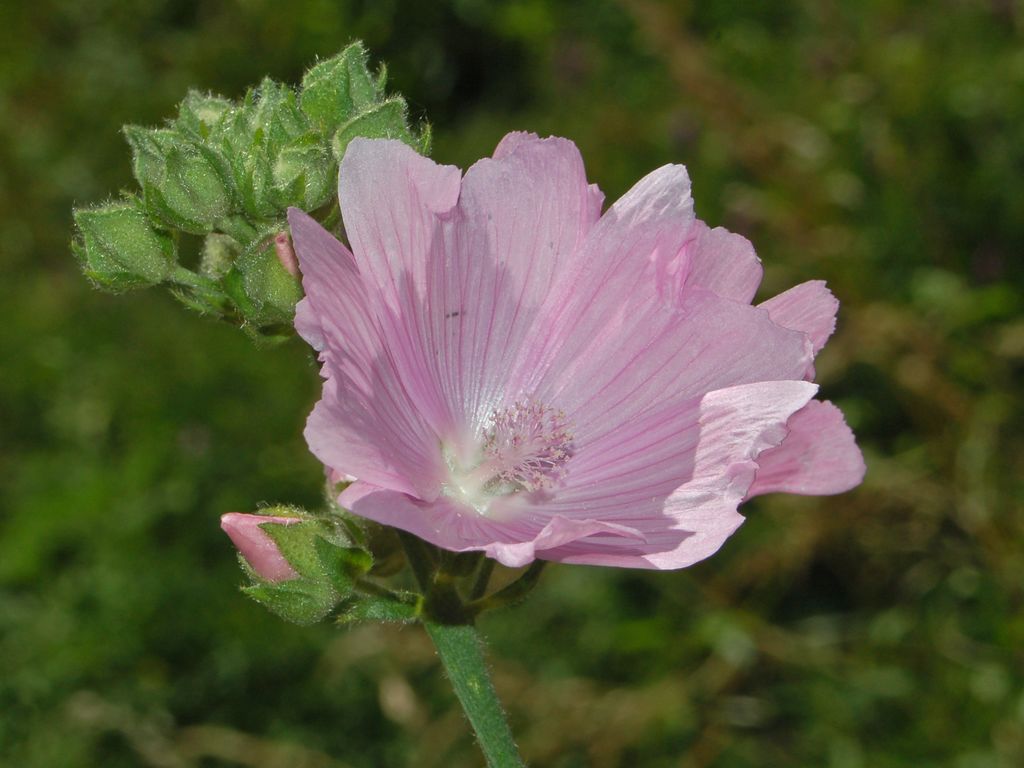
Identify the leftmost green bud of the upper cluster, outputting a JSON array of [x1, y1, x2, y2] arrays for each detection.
[[73, 202, 177, 291]]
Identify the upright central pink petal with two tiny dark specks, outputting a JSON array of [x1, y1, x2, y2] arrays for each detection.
[[424, 134, 594, 434]]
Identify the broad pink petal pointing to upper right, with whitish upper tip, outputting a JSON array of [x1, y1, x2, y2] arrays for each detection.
[[508, 166, 811, 436]]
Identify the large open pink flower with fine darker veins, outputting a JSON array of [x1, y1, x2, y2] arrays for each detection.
[[289, 133, 864, 568]]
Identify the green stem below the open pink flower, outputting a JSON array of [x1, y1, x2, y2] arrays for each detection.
[[423, 620, 525, 768]]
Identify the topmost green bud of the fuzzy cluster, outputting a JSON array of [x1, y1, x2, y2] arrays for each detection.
[[302, 42, 387, 135]]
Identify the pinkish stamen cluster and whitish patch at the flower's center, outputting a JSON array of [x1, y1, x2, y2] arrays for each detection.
[[447, 400, 573, 514]]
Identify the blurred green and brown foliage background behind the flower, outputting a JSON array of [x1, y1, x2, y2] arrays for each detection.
[[0, 0, 1024, 768]]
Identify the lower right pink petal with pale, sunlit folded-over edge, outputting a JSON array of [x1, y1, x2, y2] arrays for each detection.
[[541, 381, 817, 568]]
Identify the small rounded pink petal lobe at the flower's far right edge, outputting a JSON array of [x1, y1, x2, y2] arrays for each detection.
[[748, 400, 865, 497]]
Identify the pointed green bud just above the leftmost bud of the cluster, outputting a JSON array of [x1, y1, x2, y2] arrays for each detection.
[[125, 126, 231, 234]]
